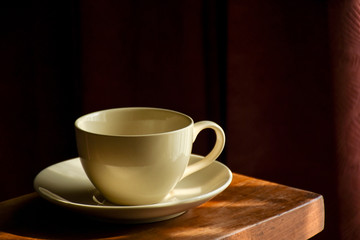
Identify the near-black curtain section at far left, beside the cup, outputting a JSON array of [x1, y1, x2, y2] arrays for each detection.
[[0, 1, 82, 200]]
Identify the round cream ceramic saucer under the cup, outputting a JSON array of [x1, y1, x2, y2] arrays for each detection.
[[34, 154, 232, 223]]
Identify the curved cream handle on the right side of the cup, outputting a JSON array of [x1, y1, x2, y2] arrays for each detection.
[[181, 121, 225, 179]]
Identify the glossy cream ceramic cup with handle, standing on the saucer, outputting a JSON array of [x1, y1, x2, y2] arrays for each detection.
[[75, 108, 225, 205]]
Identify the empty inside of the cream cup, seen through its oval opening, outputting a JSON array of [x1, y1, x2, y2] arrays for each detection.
[[75, 108, 193, 136]]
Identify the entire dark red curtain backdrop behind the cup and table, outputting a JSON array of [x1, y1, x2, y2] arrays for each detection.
[[0, 0, 360, 239]]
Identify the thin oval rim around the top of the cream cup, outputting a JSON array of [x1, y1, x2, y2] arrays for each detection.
[[74, 107, 194, 137]]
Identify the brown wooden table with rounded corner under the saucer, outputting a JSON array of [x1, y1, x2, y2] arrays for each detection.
[[0, 174, 324, 240]]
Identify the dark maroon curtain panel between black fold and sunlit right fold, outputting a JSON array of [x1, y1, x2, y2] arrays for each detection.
[[226, 0, 338, 239]]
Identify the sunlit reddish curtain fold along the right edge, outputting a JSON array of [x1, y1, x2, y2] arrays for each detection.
[[329, 0, 360, 239]]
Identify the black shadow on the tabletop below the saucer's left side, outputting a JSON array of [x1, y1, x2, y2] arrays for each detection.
[[0, 195, 145, 239]]
